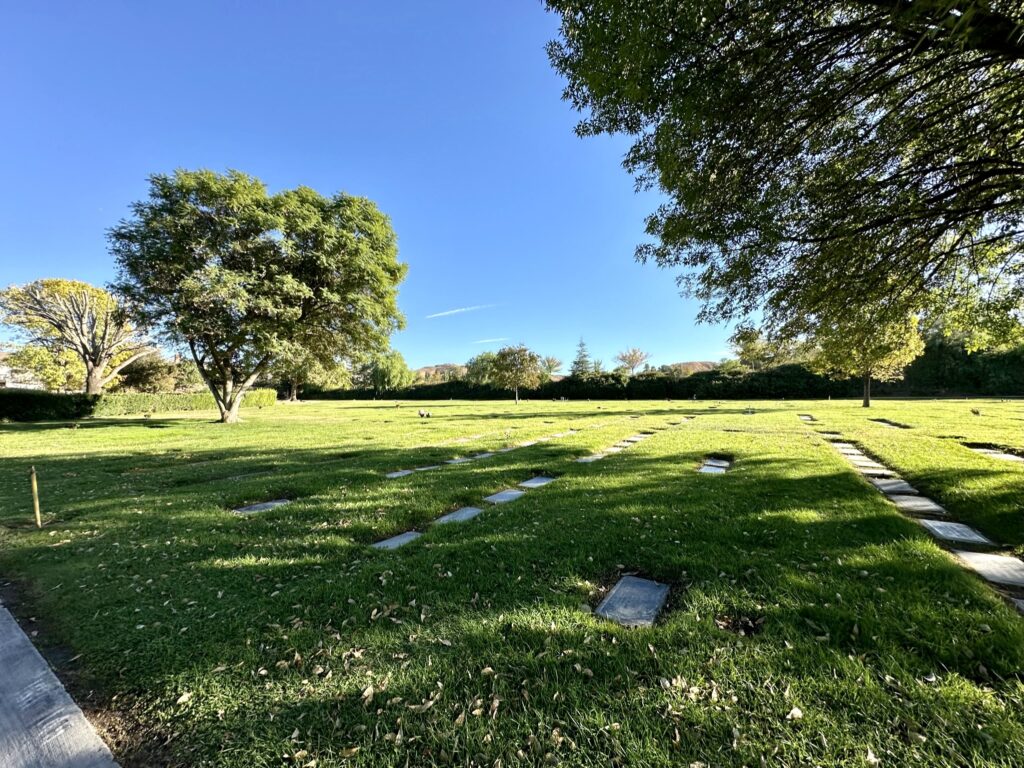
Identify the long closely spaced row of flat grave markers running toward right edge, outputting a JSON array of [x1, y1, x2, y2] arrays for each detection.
[[819, 423, 1024, 612]]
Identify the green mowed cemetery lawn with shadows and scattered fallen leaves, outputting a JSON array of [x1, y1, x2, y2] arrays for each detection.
[[0, 400, 1024, 768]]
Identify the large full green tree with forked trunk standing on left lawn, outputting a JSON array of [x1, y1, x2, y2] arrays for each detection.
[[110, 170, 406, 422]]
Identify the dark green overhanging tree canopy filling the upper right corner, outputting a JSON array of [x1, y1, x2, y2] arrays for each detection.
[[548, 0, 1024, 333]]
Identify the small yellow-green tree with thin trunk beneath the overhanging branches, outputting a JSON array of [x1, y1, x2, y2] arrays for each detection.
[[813, 309, 925, 408]]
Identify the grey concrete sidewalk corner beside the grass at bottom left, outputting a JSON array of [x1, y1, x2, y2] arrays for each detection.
[[0, 604, 117, 768]]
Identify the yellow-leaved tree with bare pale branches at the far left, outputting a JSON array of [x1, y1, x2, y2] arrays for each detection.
[[0, 280, 156, 394]]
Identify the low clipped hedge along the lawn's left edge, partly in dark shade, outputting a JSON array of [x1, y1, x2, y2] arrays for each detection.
[[0, 389, 278, 421]]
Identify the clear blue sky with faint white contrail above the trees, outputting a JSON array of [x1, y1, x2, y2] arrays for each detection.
[[0, 0, 728, 367]]
